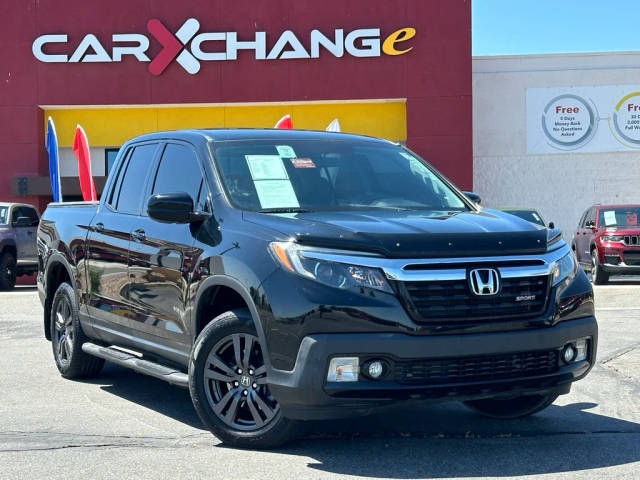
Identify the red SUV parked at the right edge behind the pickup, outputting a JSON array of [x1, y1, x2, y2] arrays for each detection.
[[572, 205, 640, 285]]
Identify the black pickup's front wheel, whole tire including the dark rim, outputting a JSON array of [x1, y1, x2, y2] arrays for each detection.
[[189, 309, 297, 449]]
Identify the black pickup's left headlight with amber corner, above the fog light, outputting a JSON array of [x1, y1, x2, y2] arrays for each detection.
[[269, 242, 393, 293]]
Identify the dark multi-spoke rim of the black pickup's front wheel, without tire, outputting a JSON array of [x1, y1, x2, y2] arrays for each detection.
[[203, 333, 280, 431]]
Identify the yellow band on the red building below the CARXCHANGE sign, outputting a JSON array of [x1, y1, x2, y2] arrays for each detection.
[[44, 99, 407, 147]]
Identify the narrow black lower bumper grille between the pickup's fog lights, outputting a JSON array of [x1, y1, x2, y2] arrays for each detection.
[[394, 350, 559, 384]]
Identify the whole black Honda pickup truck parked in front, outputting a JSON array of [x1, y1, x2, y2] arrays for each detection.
[[38, 129, 598, 448]]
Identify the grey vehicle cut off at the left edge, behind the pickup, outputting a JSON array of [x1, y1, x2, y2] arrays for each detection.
[[0, 203, 40, 290]]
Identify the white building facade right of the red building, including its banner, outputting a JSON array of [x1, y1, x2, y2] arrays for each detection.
[[473, 52, 640, 240]]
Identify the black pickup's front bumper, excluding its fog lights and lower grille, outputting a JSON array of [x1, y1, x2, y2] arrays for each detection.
[[268, 317, 598, 420]]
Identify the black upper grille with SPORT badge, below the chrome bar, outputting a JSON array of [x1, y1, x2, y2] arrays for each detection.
[[403, 275, 549, 322]]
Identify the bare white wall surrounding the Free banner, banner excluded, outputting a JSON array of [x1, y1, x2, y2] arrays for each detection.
[[473, 52, 640, 240]]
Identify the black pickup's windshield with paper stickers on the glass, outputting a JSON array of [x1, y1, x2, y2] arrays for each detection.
[[214, 140, 468, 212]]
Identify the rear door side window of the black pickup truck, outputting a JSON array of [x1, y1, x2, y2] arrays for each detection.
[[114, 143, 158, 215]]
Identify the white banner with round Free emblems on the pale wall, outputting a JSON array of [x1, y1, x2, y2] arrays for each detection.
[[526, 85, 640, 154]]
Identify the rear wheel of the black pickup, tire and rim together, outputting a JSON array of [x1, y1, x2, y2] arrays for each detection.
[[51, 283, 104, 379]]
